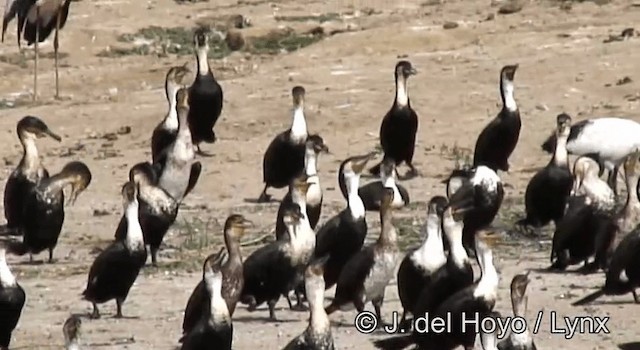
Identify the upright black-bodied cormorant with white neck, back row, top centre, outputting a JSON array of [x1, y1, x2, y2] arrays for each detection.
[[258, 86, 308, 203]]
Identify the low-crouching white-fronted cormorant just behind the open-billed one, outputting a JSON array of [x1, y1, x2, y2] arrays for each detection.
[[348, 157, 409, 211]]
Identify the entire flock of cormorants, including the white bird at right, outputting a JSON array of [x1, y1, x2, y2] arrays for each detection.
[[0, 22, 640, 350]]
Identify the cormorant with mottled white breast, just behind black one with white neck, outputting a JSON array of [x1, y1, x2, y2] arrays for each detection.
[[115, 162, 180, 266]]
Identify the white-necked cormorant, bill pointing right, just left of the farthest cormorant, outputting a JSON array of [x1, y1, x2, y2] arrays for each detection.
[[151, 63, 191, 163]]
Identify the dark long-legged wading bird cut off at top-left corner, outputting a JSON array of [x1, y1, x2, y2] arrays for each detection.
[[2, 0, 71, 101]]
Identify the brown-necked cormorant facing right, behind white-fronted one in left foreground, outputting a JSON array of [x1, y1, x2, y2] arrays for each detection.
[[182, 214, 253, 335]]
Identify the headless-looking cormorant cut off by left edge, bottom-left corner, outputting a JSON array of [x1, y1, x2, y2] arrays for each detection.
[[0, 243, 26, 350]]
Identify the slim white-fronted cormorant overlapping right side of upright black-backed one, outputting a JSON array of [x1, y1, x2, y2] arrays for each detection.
[[276, 135, 329, 240]]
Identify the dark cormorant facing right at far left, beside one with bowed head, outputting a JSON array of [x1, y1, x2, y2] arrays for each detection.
[[4, 116, 62, 235]]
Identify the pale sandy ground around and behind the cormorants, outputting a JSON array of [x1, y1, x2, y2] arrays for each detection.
[[0, 0, 640, 349]]
